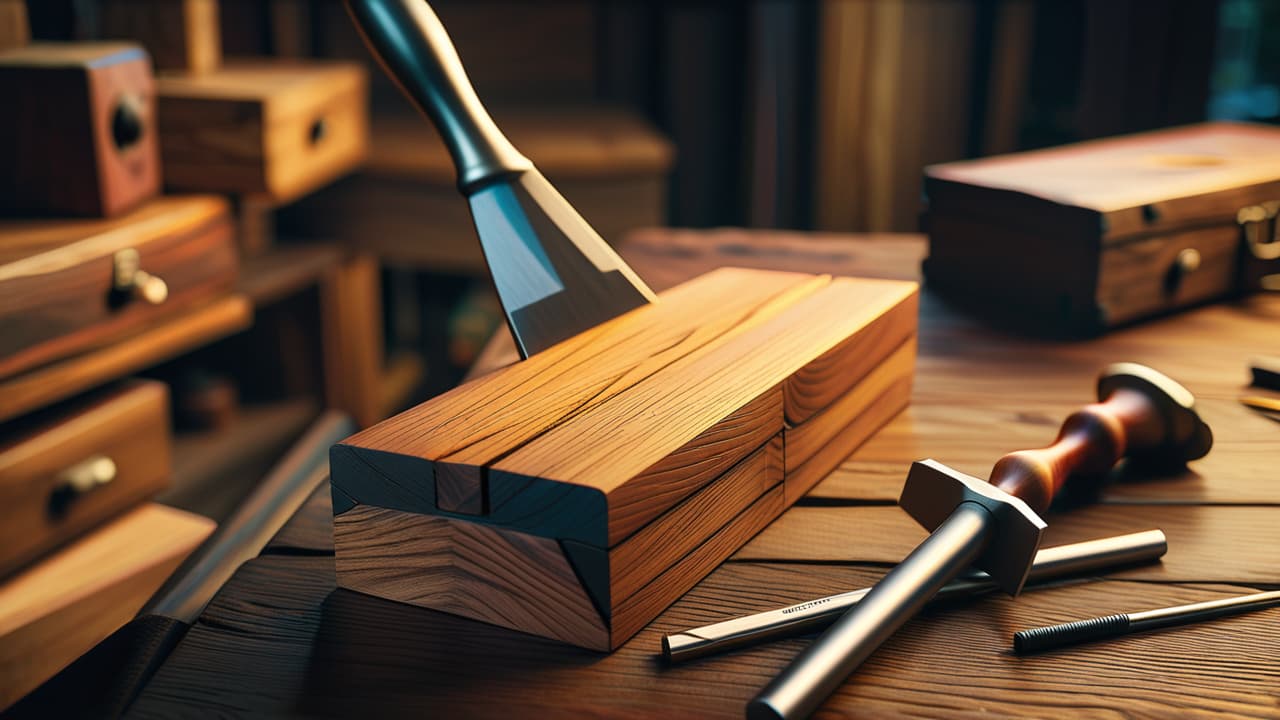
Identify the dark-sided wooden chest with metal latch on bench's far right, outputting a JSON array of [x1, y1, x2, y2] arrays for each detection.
[[924, 123, 1280, 334]]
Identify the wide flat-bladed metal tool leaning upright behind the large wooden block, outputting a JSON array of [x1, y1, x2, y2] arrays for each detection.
[[347, 0, 655, 357]]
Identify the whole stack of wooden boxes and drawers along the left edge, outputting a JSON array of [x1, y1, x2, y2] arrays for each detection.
[[0, 14, 222, 708]]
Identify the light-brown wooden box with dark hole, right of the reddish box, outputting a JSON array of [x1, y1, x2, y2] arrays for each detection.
[[156, 60, 369, 202]]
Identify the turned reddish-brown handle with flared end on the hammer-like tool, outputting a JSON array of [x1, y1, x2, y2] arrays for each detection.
[[991, 363, 1213, 512]]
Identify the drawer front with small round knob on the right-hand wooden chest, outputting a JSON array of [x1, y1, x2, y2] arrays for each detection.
[[1098, 224, 1240, 325]]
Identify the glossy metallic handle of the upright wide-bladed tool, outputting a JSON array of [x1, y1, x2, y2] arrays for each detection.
[[347, 0, 534, 195]]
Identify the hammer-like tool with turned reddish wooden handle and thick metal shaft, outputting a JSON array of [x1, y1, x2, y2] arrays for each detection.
[[746, 363, 1213, 720]]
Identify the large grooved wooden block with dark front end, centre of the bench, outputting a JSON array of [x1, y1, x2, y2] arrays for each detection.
[[330, 268, 916, 651]]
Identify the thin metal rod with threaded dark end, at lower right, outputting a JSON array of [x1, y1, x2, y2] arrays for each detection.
[[1014, 591, 1280, 655]]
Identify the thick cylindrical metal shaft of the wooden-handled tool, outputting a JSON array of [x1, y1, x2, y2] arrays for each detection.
[[746, 501, 995, 720]]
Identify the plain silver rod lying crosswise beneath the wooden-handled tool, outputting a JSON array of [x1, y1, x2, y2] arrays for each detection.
[[662, 530, 1169, 662]]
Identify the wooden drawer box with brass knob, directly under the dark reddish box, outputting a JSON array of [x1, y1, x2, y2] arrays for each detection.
[[0, 196, 237, 378]]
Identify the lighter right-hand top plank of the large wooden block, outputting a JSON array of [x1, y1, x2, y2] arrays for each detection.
[[489, 271, 915, 544]]
